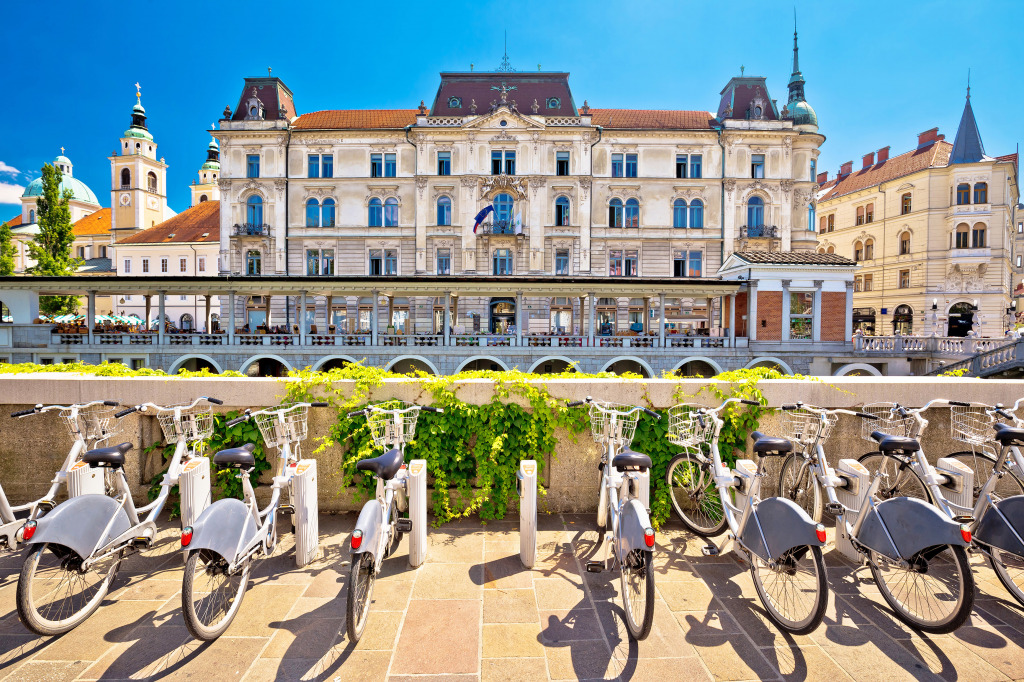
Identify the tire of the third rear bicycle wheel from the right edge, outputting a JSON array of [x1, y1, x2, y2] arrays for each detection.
[[751, 545, 828, 635]]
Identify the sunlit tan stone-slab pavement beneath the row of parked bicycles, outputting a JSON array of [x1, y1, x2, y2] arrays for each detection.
[[0, 514, 1024, 682]]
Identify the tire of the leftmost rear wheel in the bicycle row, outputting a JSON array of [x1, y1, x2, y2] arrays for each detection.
[[15, 543, 124, 637]]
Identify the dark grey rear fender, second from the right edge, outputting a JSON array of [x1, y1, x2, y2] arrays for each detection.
[[857, 498, 967, 559]]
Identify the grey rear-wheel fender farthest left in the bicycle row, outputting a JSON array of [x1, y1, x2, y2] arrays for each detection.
[[28, 495, 131, 558]]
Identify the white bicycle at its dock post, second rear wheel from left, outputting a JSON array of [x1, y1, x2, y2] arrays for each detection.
[[181, 402, 328, 641]]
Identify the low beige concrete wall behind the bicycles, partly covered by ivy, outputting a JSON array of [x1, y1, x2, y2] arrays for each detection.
[[0, 374, 1024, 511]]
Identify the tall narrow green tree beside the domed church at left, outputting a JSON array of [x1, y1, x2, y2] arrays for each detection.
[[29, 164, 80, 315]]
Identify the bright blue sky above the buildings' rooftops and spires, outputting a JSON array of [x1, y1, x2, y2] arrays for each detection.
[[0, 0, 1024, 219]]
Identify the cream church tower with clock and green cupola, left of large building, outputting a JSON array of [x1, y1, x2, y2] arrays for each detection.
[[110, 83, 172, 242]]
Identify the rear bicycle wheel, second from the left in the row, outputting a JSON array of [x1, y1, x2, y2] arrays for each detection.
[[181, 550, 252, 642]]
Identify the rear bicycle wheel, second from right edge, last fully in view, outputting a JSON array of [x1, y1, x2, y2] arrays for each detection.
[[870, 545, 974, 634]]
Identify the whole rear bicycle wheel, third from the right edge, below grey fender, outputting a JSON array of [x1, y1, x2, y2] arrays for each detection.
[[751, 545, 828, 635]]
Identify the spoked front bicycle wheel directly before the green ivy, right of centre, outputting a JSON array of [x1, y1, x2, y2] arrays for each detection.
[[665, 452, 726, 538]]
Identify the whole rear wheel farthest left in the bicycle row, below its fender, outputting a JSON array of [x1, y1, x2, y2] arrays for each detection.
[[16, 544, 124, 636]]
